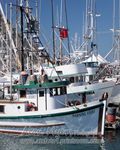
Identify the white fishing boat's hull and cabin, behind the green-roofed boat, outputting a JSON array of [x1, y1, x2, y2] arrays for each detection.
[[41, 61, 115, 101]]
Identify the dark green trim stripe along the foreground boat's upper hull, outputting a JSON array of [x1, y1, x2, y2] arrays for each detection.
[[0, 104, 104, 119]]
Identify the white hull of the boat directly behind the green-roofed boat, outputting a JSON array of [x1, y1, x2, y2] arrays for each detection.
[[67, 81, 115, 102]]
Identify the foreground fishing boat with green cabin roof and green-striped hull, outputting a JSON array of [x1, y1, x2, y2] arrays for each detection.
[[0, 77, 106, 135]]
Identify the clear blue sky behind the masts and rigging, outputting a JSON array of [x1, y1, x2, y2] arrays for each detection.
[[0, 0, 119, 61]]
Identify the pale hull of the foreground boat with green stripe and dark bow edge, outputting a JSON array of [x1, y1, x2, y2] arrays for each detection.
[[0, 100, 106, 135]]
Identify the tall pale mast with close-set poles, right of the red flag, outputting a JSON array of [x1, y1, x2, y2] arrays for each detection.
[[84, 0, 100, 55]]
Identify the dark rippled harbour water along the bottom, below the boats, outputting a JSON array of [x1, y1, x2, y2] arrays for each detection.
[[0, 130, 120, 150]]
